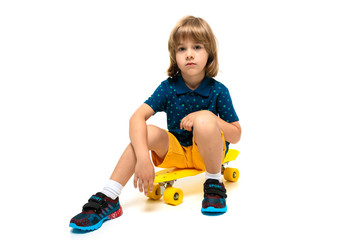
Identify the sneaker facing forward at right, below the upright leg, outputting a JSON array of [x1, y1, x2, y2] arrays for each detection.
[[201, 179, 227, 215]]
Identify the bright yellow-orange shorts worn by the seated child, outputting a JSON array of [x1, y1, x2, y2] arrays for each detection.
[[151, 131, 226, 170]]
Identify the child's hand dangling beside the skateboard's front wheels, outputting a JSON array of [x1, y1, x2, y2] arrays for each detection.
[[134, 160, 155, 196]]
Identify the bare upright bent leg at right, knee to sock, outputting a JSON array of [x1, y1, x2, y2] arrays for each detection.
[[193, 115, 223, 174]]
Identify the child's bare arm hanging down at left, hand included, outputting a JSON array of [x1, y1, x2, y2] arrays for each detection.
[[130, 104, 155, 195]]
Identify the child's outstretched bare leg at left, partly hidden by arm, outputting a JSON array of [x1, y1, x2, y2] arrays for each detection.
[[110, 125, 169, 186]]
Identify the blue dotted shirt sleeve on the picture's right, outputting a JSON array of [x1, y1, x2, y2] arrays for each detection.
[[216, 86, 239, 123]]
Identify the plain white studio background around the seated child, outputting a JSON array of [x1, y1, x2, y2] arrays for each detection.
[[0, 0, 360, 239]]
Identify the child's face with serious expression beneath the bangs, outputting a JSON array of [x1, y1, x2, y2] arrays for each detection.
[[176, 39, 209, 80]]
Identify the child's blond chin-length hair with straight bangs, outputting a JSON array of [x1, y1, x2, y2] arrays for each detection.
[[167, 16, 219, 77]]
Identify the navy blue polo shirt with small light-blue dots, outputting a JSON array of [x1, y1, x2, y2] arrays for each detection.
[[145, 75, 239, 149]]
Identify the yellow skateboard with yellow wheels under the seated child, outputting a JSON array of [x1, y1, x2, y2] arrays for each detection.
[[148, 149, 240, 205]]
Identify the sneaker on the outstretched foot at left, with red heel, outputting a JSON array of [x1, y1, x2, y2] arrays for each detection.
[[70, 192, 123, 231]]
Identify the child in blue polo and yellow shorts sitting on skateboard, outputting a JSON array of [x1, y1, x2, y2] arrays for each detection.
[[70, 16, 241, 230]]
